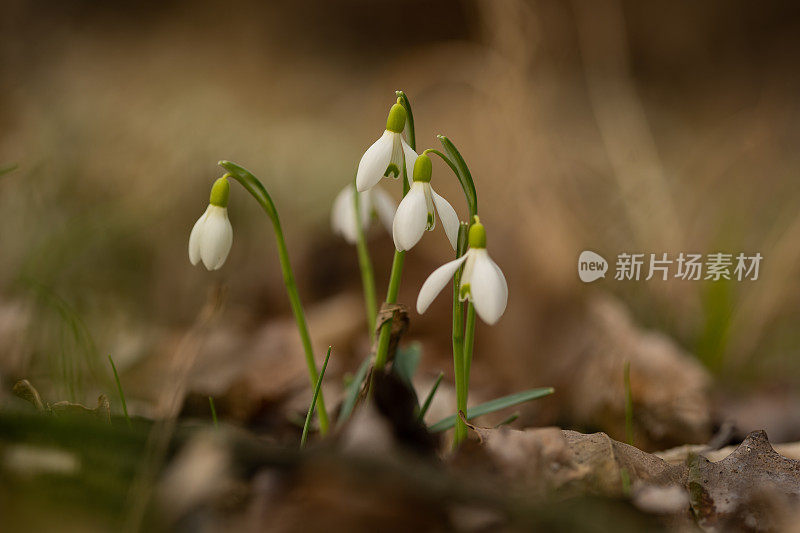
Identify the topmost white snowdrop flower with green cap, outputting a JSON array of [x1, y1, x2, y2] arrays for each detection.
[[356, 98, 417, 192]]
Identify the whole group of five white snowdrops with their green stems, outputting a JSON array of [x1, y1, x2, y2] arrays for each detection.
[[189, 91, 531, 445]]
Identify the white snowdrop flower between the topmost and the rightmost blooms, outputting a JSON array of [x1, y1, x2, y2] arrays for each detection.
[[392, 152, 458, 252]]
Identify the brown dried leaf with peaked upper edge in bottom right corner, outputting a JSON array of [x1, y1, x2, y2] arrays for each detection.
[[688, 431, 800, 531]]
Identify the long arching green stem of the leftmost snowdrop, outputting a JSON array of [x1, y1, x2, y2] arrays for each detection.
[[219, 161, 330, 435]]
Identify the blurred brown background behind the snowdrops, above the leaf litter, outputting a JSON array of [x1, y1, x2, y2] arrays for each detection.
[[0, 0, 800, 440]]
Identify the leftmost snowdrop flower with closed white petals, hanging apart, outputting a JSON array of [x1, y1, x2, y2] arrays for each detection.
[[189, 176, 233, 270]]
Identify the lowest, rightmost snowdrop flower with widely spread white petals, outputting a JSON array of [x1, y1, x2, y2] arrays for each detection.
[[417, 216, 508, 324]]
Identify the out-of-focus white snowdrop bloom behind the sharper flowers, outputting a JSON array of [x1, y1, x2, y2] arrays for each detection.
[[331, 183, 397, 244]]
